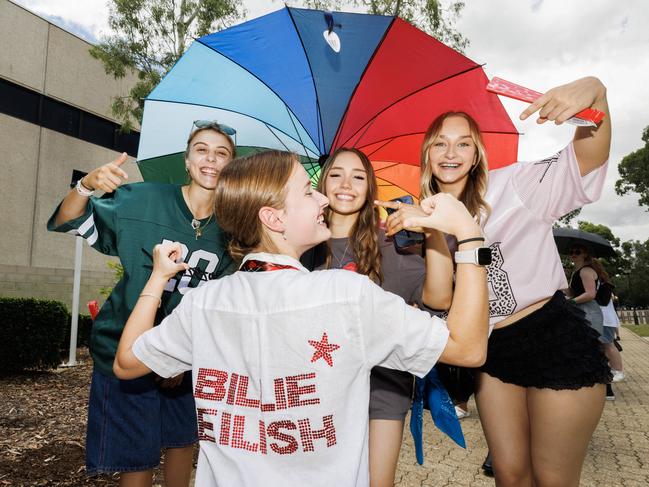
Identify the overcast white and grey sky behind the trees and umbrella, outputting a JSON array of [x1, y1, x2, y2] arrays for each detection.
[[13, 0, 649, 244]]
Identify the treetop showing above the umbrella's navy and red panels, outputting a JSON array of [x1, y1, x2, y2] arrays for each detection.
[[299, 0, 469, 52]]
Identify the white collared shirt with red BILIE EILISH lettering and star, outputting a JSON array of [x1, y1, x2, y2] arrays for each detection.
[[133, 253, 448, 487]]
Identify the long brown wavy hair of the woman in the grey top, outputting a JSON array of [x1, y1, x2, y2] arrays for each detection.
[[317, 147, 383, 284]]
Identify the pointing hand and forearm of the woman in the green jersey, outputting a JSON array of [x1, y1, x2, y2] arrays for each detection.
[[55, 152, 128, 226]]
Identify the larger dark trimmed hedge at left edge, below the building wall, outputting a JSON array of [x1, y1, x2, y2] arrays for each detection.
[[0, 298, 69, 372]]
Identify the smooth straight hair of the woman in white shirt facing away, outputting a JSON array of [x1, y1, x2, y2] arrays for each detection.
[[214, 150, 299, 261]]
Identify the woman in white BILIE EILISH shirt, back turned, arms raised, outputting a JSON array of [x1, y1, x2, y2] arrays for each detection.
[[114, 151, 488, 487]]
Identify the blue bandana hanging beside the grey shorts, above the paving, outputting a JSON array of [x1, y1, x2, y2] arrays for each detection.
[[410, 368, 466, 465]]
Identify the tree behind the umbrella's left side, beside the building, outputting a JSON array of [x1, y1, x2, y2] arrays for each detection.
[[90, 0, 243, 131]]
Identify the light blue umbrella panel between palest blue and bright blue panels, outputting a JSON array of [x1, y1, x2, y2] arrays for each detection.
[[147, 42, 318, 156]]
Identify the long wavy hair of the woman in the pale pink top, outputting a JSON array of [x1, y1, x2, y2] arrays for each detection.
[[419, 112, 491, 224]]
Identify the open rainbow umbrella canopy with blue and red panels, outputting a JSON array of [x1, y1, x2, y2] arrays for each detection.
[[138, 7, 518, 199]]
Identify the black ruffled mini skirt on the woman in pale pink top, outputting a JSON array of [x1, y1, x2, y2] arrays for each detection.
[[479, 291, 612, 390]]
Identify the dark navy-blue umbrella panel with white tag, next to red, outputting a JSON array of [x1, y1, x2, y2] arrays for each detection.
[[288, 8, 394, 152]]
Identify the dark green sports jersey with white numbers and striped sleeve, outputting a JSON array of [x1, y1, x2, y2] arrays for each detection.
[[47, 183, 234, 376]]
